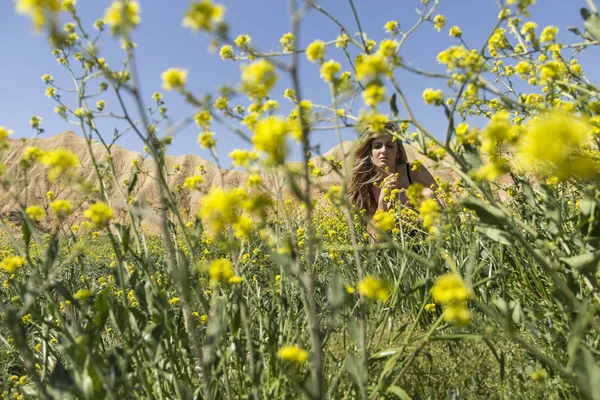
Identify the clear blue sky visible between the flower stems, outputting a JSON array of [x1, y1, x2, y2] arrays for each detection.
[[0, 0, 600, 167]]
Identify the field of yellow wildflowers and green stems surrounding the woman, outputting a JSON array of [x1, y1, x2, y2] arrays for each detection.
[[0, 0, 600, 399]]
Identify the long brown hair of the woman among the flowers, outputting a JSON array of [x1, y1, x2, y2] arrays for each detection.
[[348, 123, 408, 216]]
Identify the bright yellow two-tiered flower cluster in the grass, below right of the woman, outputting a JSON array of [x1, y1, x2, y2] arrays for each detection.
[[431, 273, 473, 325]]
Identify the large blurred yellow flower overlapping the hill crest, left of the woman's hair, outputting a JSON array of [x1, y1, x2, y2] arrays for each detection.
[[252, 117, 289, 165]]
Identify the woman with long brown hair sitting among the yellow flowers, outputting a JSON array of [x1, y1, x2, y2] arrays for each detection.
[[348, 124, 437, 234]]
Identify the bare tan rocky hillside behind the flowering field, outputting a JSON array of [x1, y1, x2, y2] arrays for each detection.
[[0, 131, 456, 230]]
